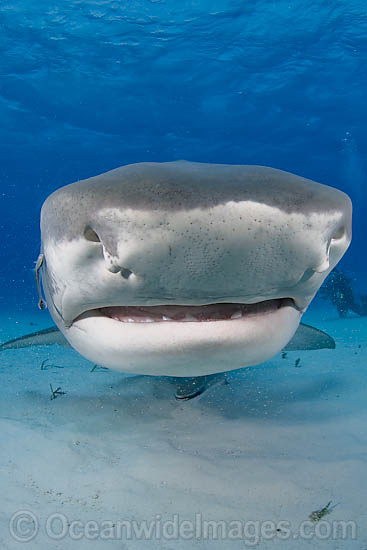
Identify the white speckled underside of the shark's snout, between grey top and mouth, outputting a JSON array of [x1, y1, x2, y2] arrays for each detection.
[[69, 207, 350, 320]]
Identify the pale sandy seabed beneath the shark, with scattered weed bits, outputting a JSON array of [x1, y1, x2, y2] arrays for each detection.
[[0, 307, 367, 550]]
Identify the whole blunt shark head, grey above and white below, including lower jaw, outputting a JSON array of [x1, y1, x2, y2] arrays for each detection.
[[41, 161, 351, 376]]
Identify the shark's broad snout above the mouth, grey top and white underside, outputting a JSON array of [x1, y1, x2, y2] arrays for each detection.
[[41, 163, 351, 326]]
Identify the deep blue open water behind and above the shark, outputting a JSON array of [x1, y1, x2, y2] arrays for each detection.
[[0, 0, 367, 309]]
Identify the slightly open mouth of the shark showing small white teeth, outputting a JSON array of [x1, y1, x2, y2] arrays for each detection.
[[98, 298, 295, 323]]
